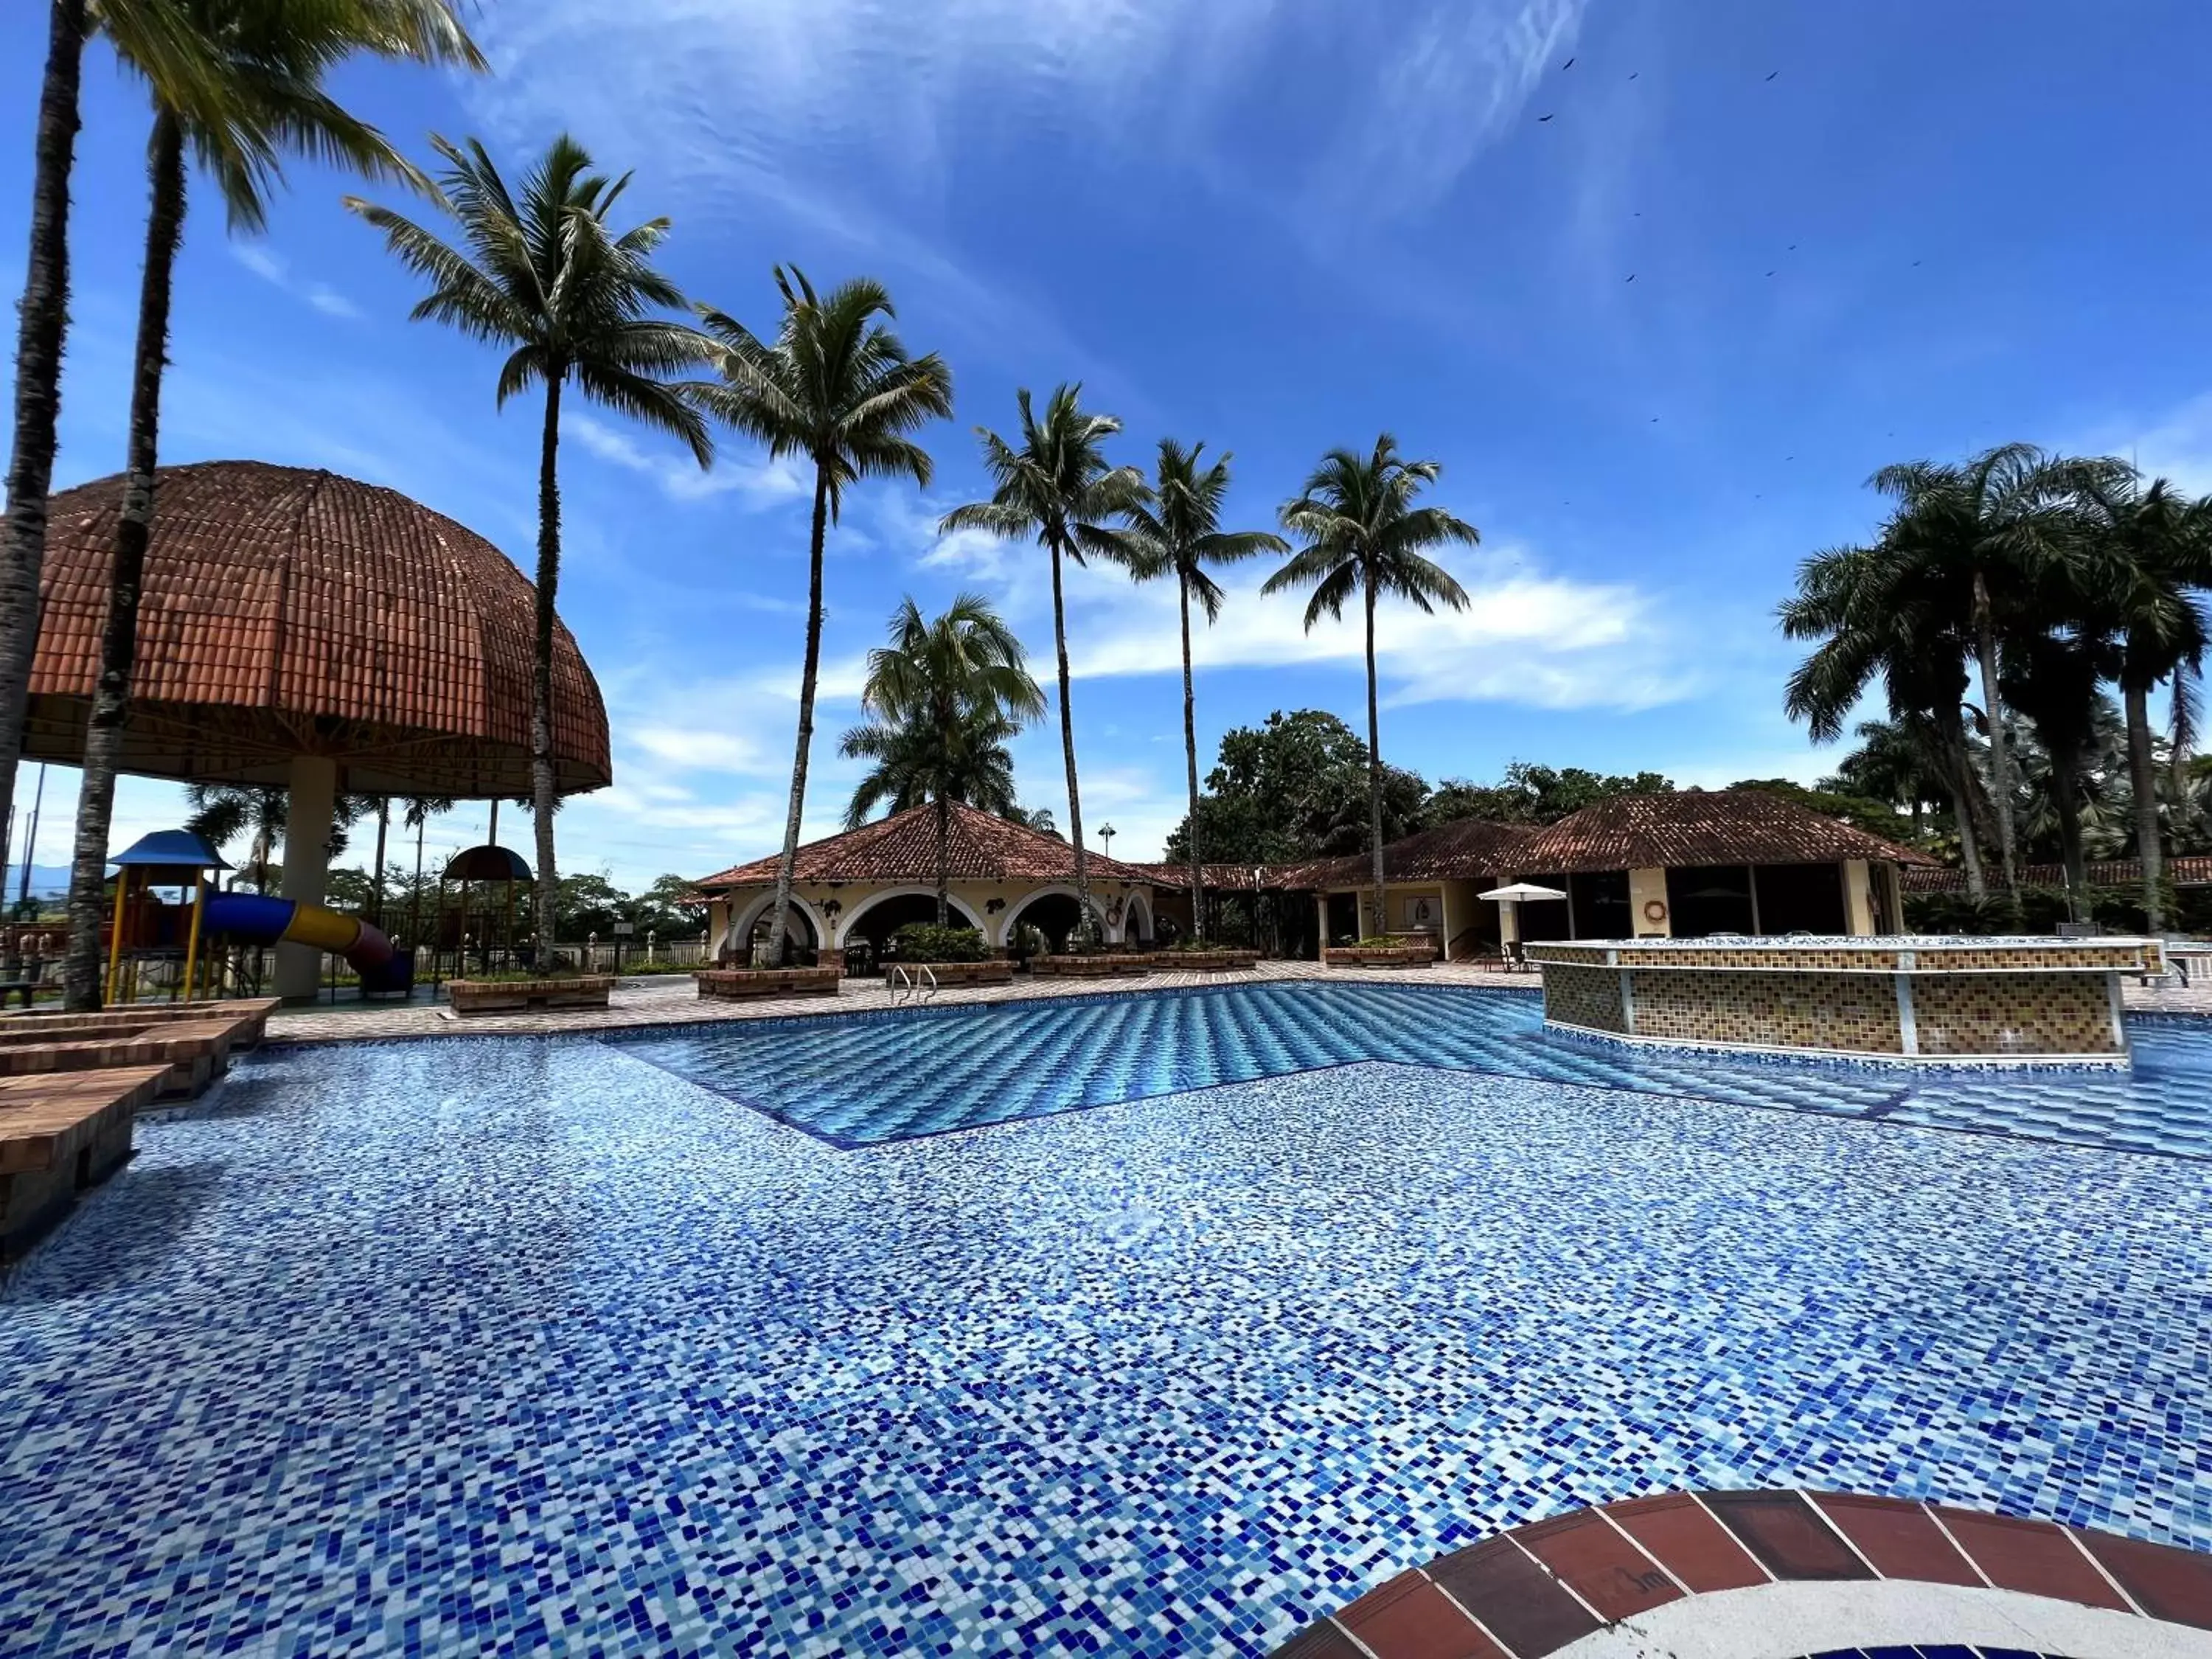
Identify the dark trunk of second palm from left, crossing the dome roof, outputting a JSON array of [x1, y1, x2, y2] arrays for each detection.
[[60, 111, 184, 1013]]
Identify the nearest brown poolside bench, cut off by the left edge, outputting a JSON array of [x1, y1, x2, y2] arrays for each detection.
[[0, 1066, 168, 1256]]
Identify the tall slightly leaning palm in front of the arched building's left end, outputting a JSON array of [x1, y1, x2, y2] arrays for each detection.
[[686, 265, 953, 962]]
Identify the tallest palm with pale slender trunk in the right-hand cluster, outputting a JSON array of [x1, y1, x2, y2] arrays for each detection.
[[1867, 442, 2119, 894]]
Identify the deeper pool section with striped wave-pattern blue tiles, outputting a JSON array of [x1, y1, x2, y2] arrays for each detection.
[[611, 982, 2212, 1157]]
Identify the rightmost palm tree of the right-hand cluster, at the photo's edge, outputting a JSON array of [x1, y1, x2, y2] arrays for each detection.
[[2081, 469, 2212, 933]]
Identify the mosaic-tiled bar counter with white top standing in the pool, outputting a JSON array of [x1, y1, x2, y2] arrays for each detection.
[[1528, 938, 2163, 1066]]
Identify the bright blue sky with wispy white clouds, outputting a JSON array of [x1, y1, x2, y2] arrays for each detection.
[[0, 0, 2212, 883]]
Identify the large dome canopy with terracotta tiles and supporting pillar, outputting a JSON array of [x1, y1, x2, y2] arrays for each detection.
[[24, 460, 613, 995]]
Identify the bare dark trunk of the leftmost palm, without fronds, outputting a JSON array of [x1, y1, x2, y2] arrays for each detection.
[[0, 0, 84, 869]]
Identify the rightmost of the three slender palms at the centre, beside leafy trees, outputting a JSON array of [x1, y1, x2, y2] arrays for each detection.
[[1261, 442, 1482, 929]]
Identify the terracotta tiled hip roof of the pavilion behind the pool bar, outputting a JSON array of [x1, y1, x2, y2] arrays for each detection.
[[1517, 790, 1933, 876]]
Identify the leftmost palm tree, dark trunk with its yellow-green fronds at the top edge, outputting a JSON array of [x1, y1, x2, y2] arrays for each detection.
[[0, 0, 237, 872]]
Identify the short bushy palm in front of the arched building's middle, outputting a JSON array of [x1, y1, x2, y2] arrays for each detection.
[[838, 593, 1044, 927]]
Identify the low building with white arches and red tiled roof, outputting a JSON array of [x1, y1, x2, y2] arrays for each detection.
[[695, 803, 1155, 953]]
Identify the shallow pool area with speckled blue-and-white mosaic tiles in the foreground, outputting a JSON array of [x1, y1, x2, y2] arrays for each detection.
[[13, 987, 2212, 1657]]
